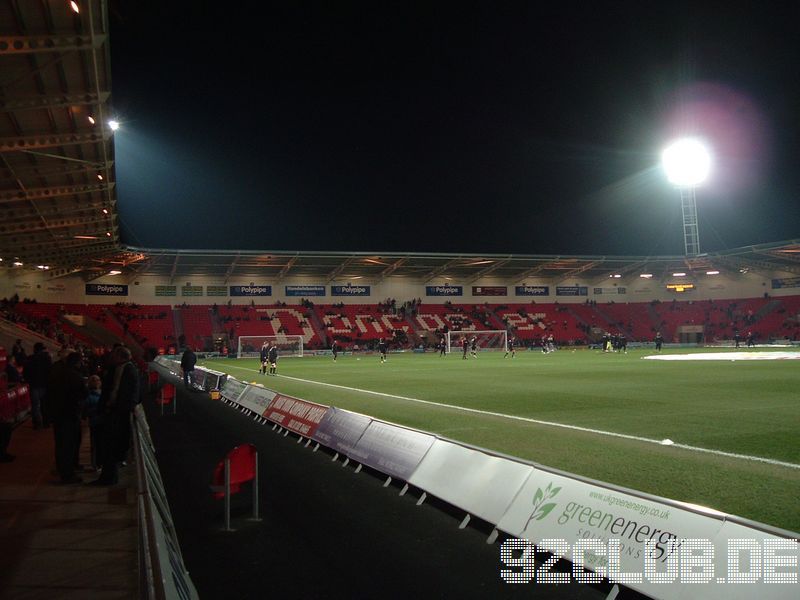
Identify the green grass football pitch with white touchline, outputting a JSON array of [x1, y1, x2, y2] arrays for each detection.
[[195, 349, 800, 531]]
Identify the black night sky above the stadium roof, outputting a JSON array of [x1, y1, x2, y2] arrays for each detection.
[[110, 0, 800, 255]]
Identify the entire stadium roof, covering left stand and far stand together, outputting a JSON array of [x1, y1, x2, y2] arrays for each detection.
[[0, 0, 800, 284]]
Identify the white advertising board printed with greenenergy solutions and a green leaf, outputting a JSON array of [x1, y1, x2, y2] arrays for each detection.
[[497, 469, 724, 599]]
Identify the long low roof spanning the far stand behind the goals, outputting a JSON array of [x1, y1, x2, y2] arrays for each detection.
[[59, 240, 800, 284]]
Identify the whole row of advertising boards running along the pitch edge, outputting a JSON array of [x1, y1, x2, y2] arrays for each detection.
[[152, 358, 800, 600]]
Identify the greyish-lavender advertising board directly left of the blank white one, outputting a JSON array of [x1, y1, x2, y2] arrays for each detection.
[[348, 421, 436, 481]]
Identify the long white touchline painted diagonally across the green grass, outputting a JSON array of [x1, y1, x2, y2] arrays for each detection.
[[281, 375, 800, 469]]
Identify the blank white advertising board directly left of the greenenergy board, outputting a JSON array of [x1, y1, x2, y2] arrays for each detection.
[[408, 439, 533, 524]]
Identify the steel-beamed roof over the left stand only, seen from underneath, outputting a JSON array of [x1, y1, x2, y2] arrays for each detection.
[[0, 0, 120, 274]]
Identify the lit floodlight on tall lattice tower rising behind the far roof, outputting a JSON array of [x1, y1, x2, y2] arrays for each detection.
[[661, 138, 711, 256]]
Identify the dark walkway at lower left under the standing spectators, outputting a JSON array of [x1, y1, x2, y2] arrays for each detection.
[[0, 421, 139, 600]]
